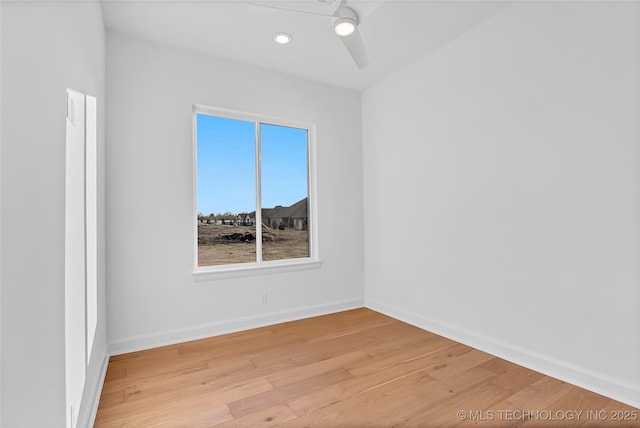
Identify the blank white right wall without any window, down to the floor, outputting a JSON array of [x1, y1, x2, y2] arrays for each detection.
[[362, 2, 640, 406]]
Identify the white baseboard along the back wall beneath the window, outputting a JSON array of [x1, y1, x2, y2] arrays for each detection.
[[108, 299, 364, 355]]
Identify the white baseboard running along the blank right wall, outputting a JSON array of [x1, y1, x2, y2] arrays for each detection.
[[365, 298, 640, 408]]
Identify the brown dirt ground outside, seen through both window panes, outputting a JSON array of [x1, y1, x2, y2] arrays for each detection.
[[198, 224, 309, 266]]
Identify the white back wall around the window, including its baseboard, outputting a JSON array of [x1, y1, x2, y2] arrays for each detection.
[[107, 32, 364, 352]]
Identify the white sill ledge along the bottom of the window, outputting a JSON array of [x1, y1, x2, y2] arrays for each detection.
[[193, 259, 322, 282]]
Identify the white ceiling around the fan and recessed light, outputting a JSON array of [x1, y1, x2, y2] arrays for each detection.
[[102, 0, 512, 91]]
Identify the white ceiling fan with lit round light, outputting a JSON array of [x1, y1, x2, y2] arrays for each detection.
[[249, 0, 369, 69]]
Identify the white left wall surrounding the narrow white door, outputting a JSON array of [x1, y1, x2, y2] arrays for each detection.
[[0, 2, 106, 428]]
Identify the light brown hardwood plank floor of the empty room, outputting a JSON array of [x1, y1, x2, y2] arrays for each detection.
[[95, 309, 640, 428]]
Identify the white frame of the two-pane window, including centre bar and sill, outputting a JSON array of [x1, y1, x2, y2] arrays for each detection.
[[192, 104, 321, 282]]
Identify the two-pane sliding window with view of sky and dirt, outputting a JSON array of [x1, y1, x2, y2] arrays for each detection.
[[193, 106, 317, 271]]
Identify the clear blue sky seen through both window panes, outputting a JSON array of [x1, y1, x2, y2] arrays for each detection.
[[196, 114, 308, 215]]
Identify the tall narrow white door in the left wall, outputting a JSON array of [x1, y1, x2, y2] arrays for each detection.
[[65, 90, 97, 428]]
